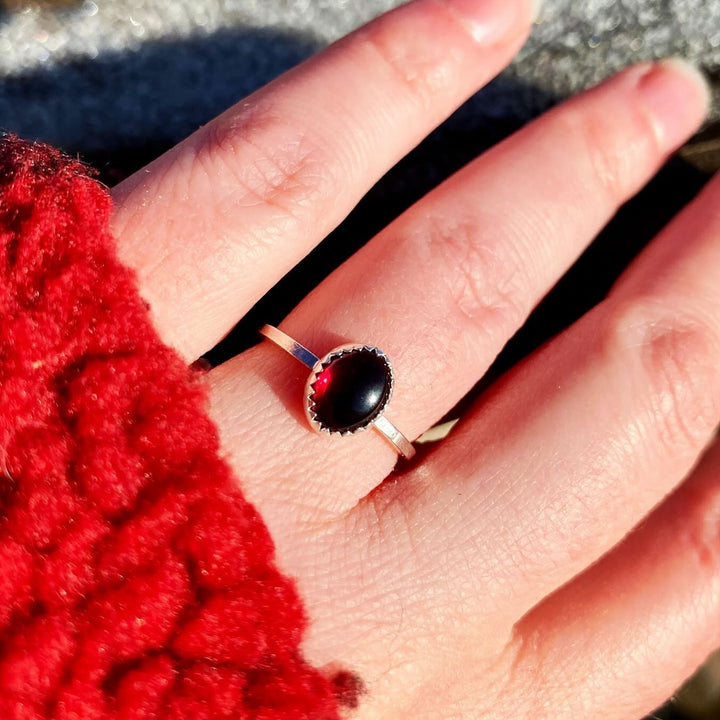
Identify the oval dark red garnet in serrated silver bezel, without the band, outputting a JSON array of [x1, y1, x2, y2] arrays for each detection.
[[308, 346, 393, 434]]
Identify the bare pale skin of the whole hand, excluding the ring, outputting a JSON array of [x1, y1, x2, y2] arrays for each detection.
[[114, 0, 720, 720]]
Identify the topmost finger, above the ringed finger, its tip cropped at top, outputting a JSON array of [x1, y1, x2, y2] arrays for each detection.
[[108, 0, 532, 359]]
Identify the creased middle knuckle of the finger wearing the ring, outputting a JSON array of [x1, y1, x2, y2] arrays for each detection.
[[422, 218, 531, 334]]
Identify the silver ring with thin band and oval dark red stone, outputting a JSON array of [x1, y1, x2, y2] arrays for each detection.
[[260, 325, 415, 460]]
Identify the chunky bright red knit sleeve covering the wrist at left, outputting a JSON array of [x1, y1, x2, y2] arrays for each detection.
[[0, 137, 352, 720]]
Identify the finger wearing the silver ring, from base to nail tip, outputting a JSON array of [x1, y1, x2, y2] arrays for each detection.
[[211, 63, 706, 528]]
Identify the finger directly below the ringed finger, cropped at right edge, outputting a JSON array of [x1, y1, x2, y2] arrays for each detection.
[[367, 165, 720, 636]]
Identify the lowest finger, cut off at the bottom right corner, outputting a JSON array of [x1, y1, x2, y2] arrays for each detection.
[[512, 442, 720, 720]]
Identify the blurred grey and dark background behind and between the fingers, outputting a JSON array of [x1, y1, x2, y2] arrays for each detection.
[[0, 0, 720, 720]]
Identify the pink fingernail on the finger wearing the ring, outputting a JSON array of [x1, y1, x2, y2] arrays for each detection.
[[638, 58, 710, 151]]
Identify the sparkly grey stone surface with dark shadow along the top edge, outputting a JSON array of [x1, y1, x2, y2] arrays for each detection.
[[0, 0, 720, 153]]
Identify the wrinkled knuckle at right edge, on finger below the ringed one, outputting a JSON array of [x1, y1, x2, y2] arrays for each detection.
[[604, 299, 720, 450]]
